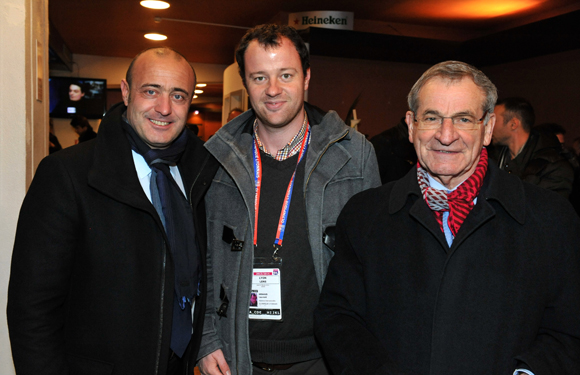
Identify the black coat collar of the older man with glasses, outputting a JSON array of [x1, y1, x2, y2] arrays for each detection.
[[389, 156, 526, 224]]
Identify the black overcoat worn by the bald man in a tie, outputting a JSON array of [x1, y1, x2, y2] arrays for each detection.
[[7, 103, 217, 375]]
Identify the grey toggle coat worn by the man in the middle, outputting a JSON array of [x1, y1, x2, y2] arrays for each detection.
[[198, 103, 380, 375]]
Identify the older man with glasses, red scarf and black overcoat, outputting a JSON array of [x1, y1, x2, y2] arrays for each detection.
[[315, 61, 580, 375]]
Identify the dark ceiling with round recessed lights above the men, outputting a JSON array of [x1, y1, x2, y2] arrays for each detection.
[[49, 0, 580, 64]]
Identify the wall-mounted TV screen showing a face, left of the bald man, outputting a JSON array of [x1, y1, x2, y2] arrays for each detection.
[[49, 77, 107, 119]]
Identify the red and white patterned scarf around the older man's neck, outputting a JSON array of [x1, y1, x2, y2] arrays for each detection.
[[417, 148, 487, 237]]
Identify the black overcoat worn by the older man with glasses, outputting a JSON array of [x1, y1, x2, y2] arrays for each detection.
[[315, 163, 580, 375]]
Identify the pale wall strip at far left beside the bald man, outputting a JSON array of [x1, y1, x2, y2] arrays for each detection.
[[0, 0, 48, 375]]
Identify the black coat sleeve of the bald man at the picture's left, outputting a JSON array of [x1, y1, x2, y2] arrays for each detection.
[[7, 157, 79, 375]]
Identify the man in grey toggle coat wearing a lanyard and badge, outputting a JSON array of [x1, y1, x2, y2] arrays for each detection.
[[199, 25, 380, 375]]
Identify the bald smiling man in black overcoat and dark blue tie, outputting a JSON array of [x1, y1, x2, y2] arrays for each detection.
[[8, 48, 217, 375]]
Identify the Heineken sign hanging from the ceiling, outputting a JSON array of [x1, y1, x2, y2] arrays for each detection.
[[288, 10, 354, 30]]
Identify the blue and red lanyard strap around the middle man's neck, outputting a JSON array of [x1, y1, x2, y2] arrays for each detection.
[[253, 127, 310, 256]]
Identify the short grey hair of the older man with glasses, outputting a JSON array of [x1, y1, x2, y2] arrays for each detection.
[[407, 61, 497, 124]]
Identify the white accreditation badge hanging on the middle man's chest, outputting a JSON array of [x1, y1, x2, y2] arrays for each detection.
[[249, 258, 282, 322]]
